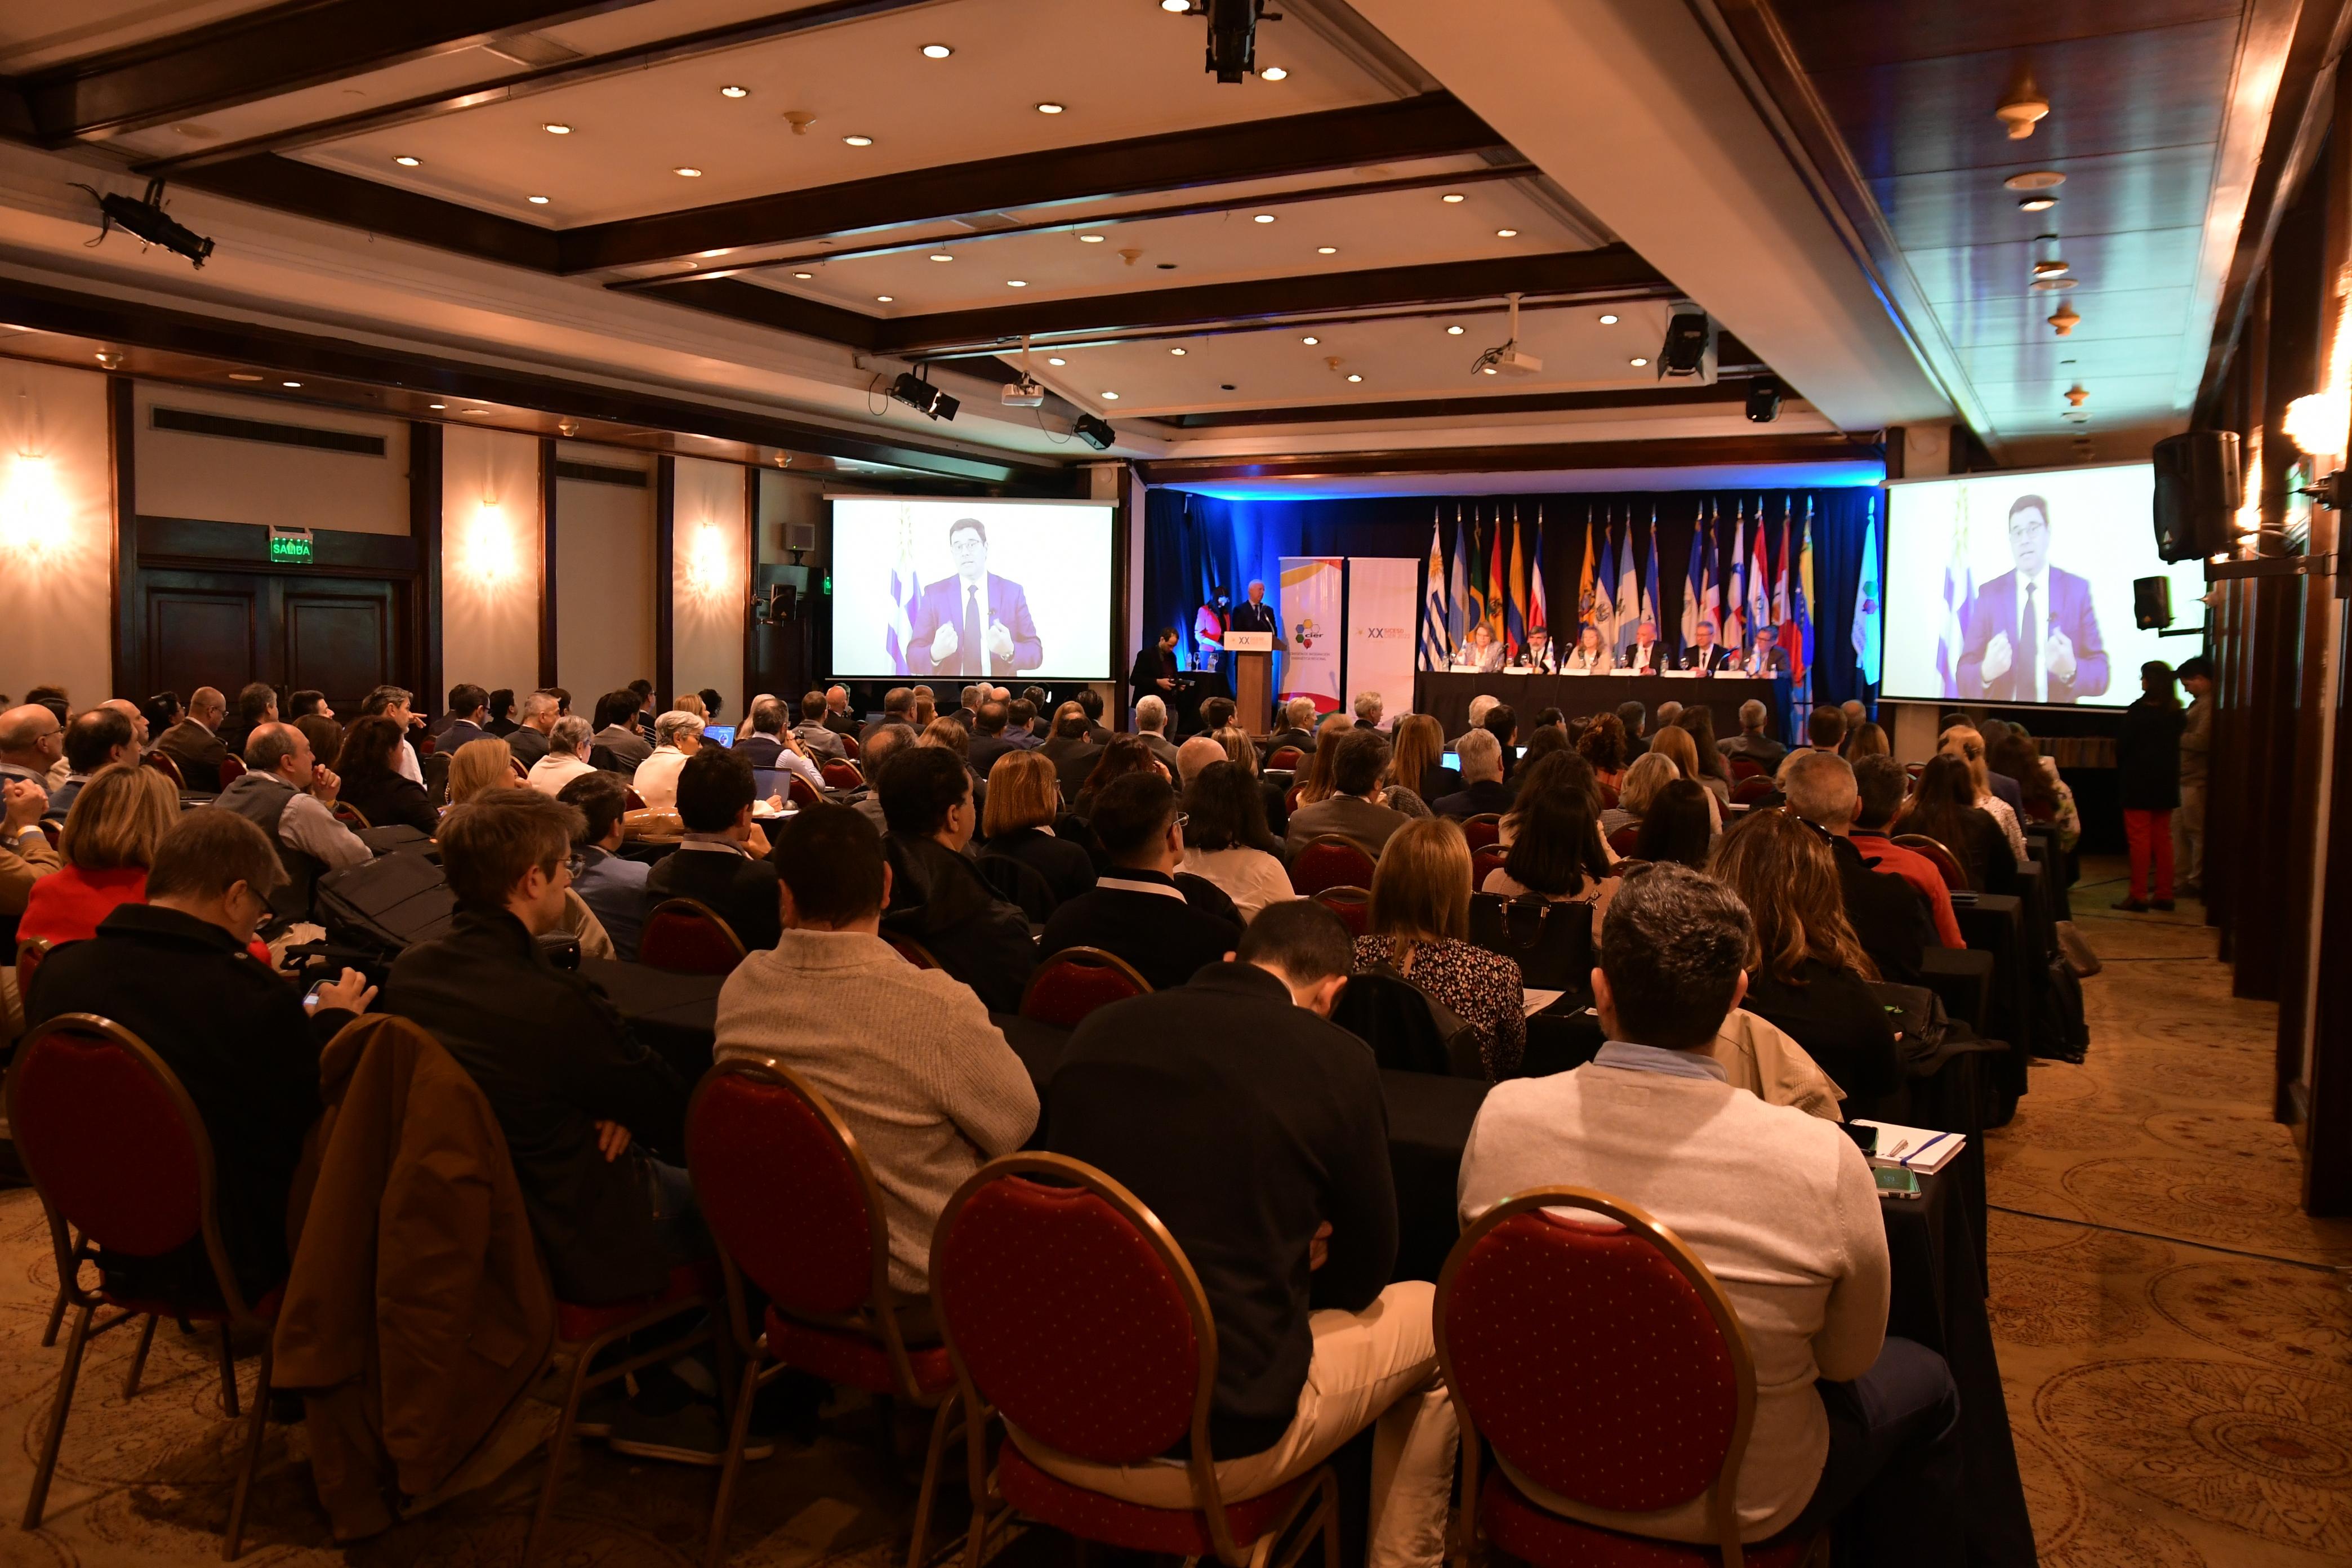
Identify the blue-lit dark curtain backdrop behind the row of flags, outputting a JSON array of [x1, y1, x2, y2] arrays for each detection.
[[1136, 487, 1886, 719]]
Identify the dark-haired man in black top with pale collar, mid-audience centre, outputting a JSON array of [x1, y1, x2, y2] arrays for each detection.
[[1037, 773, 1242, 990]]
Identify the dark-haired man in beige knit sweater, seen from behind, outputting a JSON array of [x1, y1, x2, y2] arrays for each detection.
[[712, 804, 1037, 1298]]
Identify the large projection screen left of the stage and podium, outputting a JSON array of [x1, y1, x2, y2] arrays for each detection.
[[826, 496, 1117, 681]]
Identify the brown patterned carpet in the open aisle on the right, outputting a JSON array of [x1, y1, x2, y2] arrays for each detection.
[[1985, 870, 2352, 1568]]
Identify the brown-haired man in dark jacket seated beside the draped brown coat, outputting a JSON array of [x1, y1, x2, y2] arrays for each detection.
[[384, 790, 687, 1305]]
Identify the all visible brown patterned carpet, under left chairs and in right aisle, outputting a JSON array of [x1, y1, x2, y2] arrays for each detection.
[[0, 872, 2352, 1568]]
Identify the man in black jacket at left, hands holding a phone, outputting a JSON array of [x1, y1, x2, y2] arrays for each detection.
[[26, 811, 376, 1302]]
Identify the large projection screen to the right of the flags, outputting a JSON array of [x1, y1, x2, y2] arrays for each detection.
[[1879, 463, 2204, 707]]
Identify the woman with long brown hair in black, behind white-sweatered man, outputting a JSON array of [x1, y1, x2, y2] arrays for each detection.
[[1708, 809, 1903, 1105]]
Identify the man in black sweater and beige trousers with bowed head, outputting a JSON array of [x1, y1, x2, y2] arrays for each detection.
[[1044, 901, 1456, 1568]]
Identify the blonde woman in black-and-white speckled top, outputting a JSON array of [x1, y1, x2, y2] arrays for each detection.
[[1355, 816, 1526, 1081]]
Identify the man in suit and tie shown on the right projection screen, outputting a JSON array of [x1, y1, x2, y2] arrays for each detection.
[[1959, 496, 2108, 703]]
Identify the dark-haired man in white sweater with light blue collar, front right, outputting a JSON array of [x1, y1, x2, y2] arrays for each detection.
[[1458, 865, 1966, 1563]]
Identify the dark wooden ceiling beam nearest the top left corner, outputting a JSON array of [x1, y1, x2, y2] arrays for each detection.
[[16, 0, 644, 148]]
